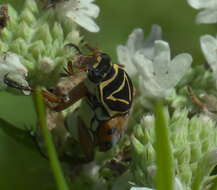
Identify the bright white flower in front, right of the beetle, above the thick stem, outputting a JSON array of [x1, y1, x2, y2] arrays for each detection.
[[134, 40, 192, 98]]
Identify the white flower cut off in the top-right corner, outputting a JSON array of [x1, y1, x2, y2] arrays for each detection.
[[188, 0, 217, 23]]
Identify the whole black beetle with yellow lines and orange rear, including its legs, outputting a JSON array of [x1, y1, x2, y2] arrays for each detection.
[[4, 44, 134, 161]]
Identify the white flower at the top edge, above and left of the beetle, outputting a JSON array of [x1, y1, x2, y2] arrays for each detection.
[[56, 0, 100, 32]]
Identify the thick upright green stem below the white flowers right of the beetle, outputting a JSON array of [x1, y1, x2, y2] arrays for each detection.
[[155, 102, 174, 190]]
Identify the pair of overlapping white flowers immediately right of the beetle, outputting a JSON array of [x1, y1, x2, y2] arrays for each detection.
[[117, 25, 192, 99]]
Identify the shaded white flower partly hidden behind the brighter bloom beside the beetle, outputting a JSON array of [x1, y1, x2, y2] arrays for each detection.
[[117, 25, 162, 76]]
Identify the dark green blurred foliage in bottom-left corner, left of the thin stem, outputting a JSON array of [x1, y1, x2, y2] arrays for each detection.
[[0, 120, 55, 190]]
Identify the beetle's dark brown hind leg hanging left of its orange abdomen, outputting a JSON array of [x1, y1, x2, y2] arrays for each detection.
[[78, 117, 94, 162]]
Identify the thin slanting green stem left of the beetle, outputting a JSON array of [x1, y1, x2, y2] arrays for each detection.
[[34, 89, 68, 190]]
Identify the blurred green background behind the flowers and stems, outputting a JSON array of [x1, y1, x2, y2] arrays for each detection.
[[0, 0, 216, 190]]
